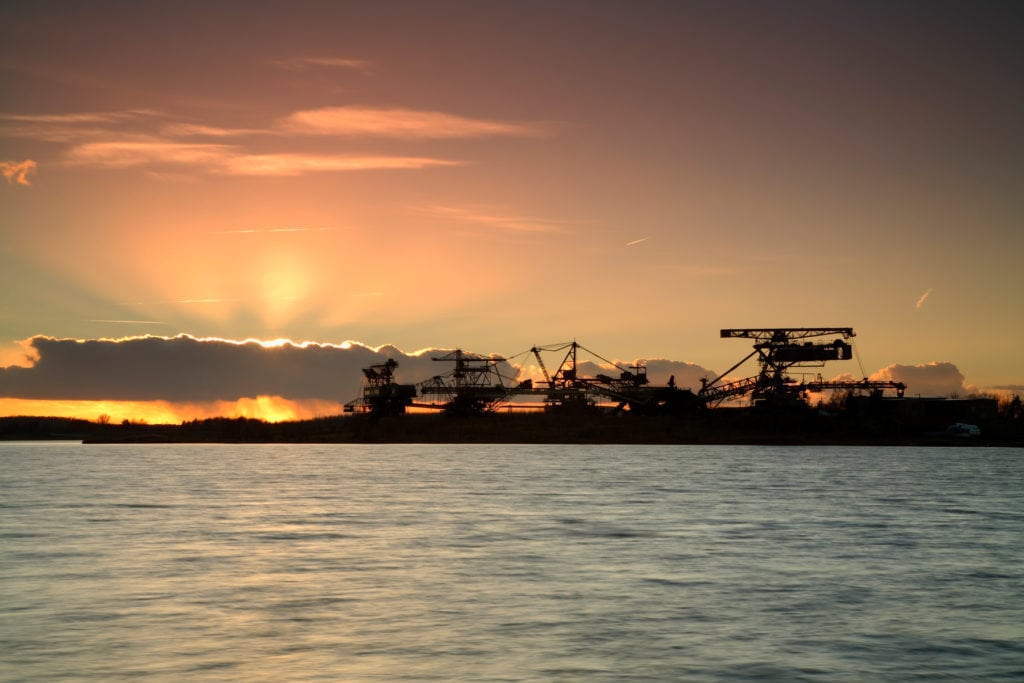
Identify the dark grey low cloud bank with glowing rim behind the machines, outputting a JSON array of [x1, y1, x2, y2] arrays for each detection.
[[0, 335, 713, 402]]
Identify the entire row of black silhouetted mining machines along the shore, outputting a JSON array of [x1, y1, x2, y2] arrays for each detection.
[[345, 327, 906, 416]]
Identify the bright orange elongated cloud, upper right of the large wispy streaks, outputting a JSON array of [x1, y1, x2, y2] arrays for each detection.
[[280, 106, 546, 138]]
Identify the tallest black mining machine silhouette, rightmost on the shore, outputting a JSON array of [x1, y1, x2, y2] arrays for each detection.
[[699, 328, 906, 405]]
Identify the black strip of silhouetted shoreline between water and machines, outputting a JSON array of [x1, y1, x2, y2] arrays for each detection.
[[0, 400, 1024, 445]]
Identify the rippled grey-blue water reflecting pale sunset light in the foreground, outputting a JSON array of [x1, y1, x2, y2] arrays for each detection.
[[0, 443, 1024, 682]]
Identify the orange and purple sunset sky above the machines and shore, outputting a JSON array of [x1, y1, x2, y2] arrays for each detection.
[[0, 0, 1024, 419]]
